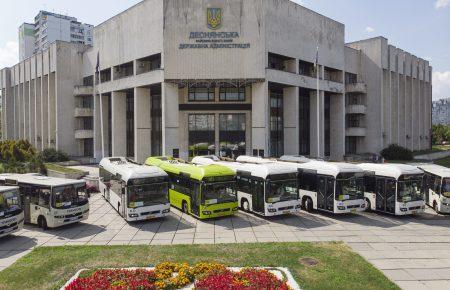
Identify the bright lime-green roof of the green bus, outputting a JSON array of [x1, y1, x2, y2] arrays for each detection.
[[145, 157, 235, 180]]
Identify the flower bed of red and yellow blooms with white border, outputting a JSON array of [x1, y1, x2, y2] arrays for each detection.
[[62, 262, 299, 290]]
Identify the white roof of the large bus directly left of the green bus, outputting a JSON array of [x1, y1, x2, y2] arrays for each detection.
[[100, 157, 167, 182]]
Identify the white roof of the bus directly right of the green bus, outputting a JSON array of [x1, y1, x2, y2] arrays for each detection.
[[192, 156, 297, 179]]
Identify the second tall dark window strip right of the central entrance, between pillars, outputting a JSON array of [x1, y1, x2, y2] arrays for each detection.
[[298, 88, 310, 155]]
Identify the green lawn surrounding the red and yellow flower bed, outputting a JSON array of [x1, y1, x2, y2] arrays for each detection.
[[0, 243, 399, 290]]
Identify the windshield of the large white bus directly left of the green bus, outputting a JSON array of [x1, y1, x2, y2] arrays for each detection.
[[127, 182, 169, 208]]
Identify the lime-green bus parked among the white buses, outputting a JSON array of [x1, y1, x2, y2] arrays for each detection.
[[145, 157, 238, 219]]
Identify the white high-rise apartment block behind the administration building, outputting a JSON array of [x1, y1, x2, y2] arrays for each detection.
[[19, 11, 94, 61]]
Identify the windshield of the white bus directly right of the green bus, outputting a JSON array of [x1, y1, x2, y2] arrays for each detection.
[[266, 179, 298, 203]]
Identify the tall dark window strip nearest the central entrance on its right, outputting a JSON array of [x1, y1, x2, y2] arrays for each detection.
[[269, 89, 284, 157]]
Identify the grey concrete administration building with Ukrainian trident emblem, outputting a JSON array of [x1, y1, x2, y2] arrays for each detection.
[[0, 0, 432, 161]]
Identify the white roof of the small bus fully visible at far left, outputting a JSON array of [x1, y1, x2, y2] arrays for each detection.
[[0, 174, 86, 187]]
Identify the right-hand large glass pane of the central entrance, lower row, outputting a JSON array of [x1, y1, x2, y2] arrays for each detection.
[[219, 114, 246, 158]]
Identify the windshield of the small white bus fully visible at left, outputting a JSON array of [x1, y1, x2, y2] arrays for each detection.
[[52, 184, 88, 209]]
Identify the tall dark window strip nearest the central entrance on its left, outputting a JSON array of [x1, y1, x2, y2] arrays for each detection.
[[150, 88, 162, 156]]
